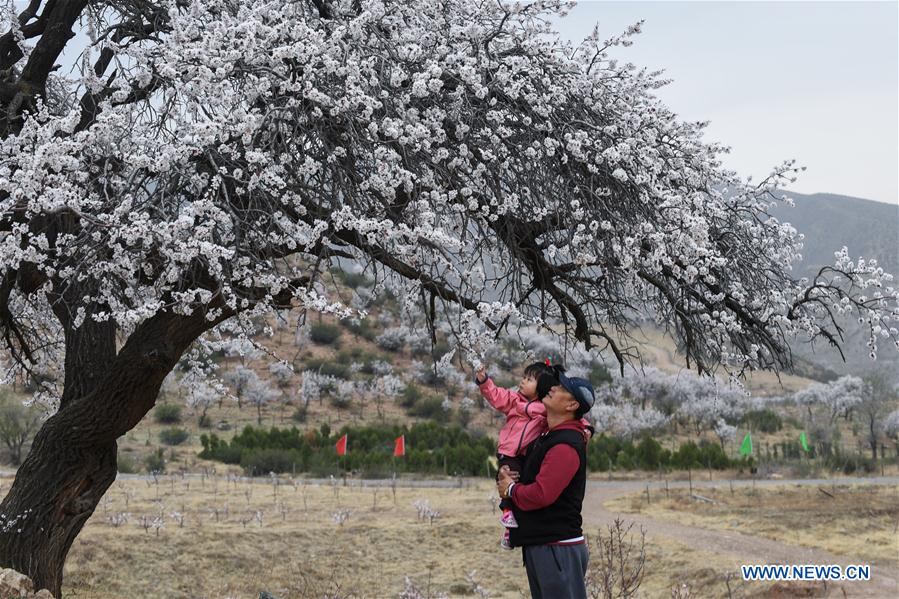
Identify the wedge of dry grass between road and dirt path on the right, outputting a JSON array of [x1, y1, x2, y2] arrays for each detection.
[[606, 484, 899, 568]]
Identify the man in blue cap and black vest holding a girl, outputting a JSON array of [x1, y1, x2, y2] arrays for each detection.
[[497, 373, 595, 599]]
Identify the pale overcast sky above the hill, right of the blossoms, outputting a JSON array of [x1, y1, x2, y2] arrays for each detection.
[[559, 0, 899, 204]]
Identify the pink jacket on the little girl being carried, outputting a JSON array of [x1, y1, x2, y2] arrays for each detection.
[[478, 377, 546, 456]]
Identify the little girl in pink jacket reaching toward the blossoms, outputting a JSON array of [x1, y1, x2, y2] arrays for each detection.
[[475, 360, 592, 549]]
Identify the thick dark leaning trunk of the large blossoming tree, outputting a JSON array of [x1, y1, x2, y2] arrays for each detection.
[[0, 313, 227, 597]]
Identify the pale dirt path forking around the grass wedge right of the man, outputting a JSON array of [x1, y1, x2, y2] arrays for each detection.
[[584, 477, 899, 599]]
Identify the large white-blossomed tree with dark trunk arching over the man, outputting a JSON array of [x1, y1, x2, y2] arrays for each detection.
[[0, 0, 899, 595]]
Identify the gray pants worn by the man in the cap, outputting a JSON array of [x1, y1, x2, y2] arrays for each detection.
[[523, 543, 587, 599]]
